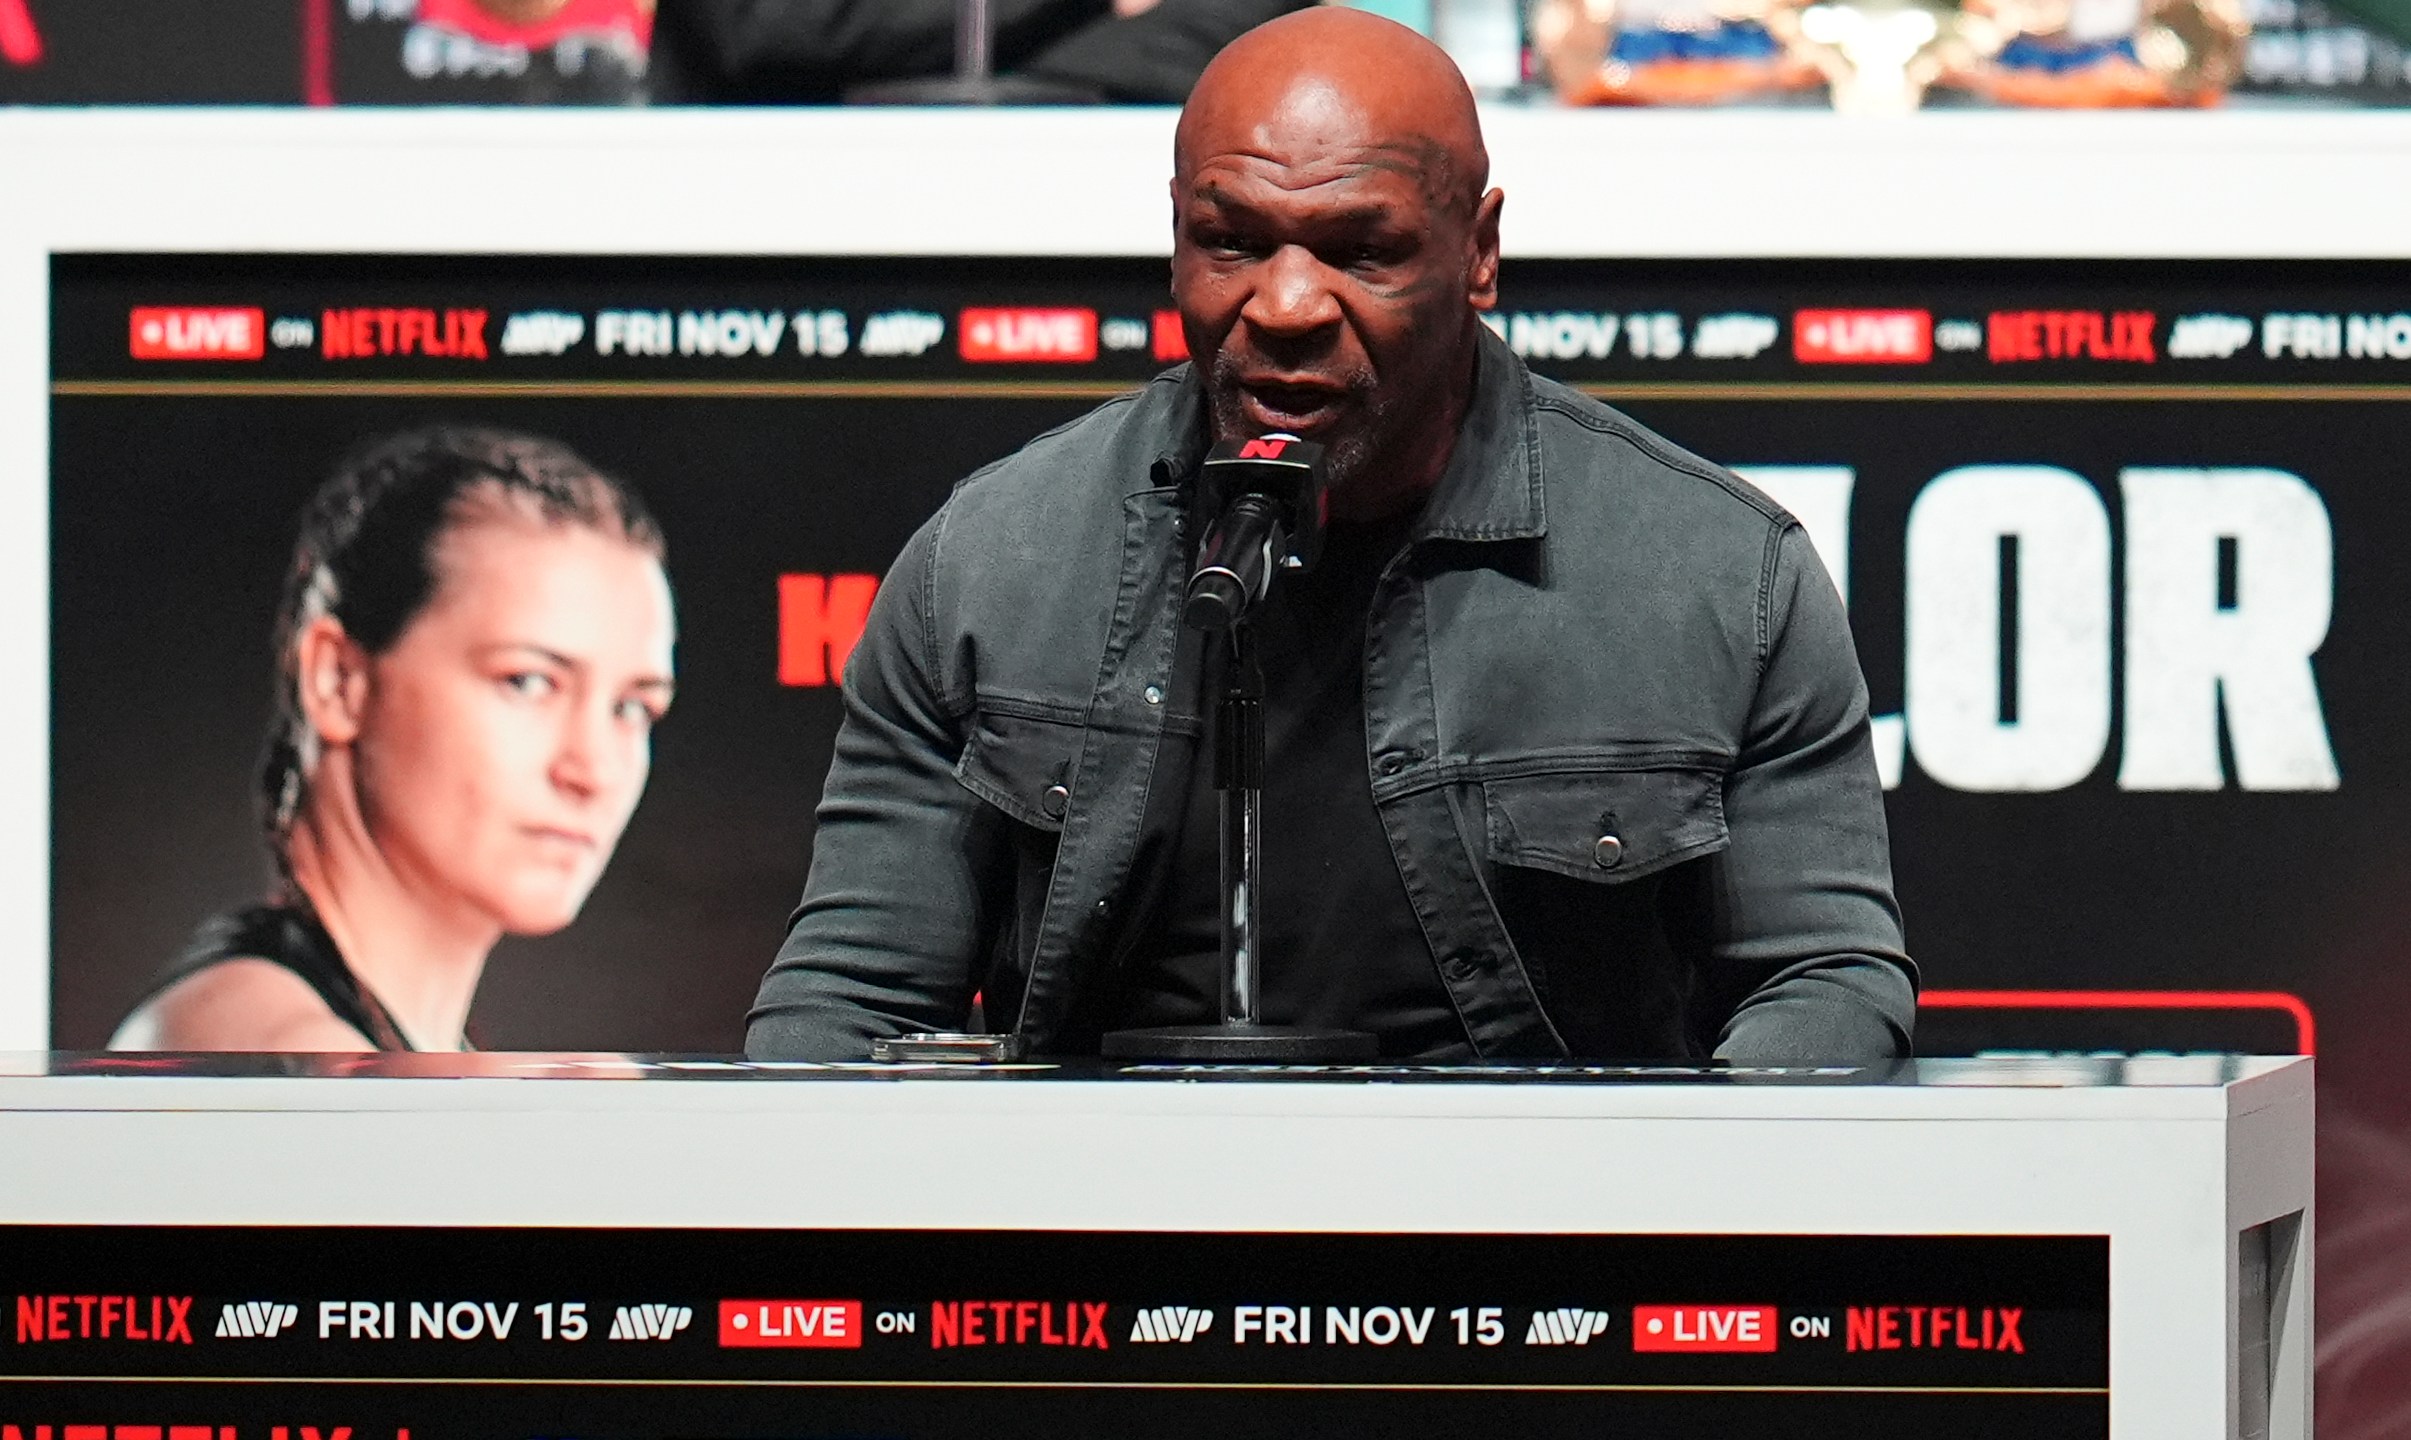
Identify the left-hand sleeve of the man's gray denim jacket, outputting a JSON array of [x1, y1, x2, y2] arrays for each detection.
[[745, 509, 1010, 1061]]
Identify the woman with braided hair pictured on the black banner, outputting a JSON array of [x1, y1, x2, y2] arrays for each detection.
[[111, 427, 675, 1052]]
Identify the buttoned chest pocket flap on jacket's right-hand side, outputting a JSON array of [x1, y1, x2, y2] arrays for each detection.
[[1480, 765, 1729, 883]]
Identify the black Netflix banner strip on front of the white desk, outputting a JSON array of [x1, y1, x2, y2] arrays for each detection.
[[0, 1225, 2110, 1440]]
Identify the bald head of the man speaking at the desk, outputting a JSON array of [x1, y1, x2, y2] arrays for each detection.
[[1172, 7, 1500, 519]]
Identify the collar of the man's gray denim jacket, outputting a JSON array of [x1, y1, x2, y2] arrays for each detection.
[[1148, 326, 1548, 540]]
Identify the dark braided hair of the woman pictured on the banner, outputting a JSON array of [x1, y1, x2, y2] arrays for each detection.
[[258, 425, 663, 890]]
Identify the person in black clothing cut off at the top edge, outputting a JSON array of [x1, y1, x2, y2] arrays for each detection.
[[651, 0, 1312, 104]]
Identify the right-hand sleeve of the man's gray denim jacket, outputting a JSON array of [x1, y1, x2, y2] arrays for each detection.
[[1705, 523, 1917, 1064]]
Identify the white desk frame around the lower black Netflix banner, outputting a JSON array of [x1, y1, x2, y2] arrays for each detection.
[[0, 1059, 2312, 1440]]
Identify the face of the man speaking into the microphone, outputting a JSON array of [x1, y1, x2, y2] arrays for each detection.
[[1172, 96, 1497, 497]]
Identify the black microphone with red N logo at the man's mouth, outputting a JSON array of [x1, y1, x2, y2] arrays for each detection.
[[1181, 434, 1331, 630]]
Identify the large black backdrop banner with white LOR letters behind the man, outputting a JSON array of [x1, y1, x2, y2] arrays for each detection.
[[51, 256, 2411, 1409]]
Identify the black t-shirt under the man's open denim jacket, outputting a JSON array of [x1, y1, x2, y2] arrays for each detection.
[[1107, 511, 1471, 1059]]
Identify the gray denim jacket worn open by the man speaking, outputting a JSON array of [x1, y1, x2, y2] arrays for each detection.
[[745, 333, 1914, 1061]]
